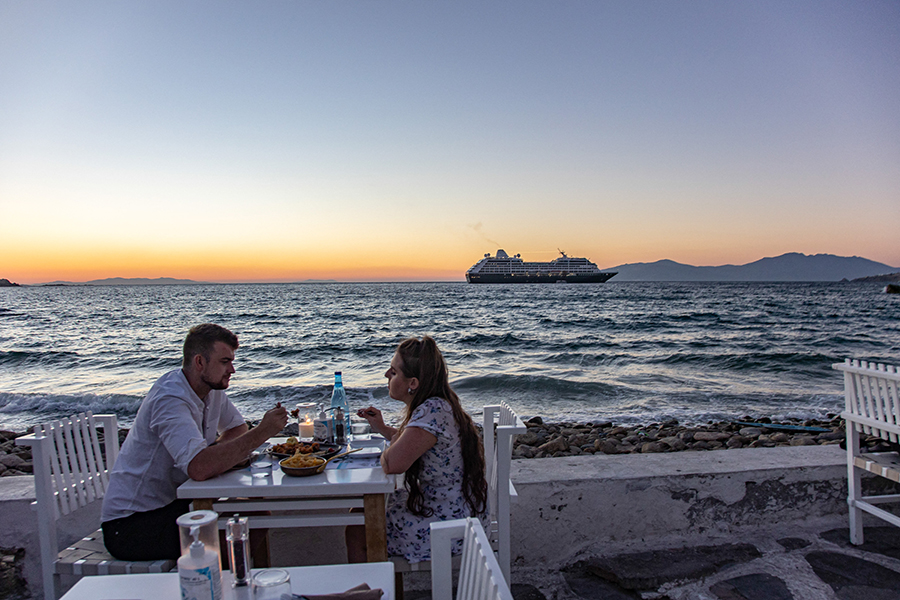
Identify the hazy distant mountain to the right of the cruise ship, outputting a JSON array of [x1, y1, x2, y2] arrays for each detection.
[[604, 252, 898, 282]]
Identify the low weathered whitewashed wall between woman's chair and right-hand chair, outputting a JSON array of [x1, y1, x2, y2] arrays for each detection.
[[511, 446, 847, 565]]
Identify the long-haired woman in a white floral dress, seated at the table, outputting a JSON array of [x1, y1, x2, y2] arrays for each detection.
[[347, 336, 487, 563]]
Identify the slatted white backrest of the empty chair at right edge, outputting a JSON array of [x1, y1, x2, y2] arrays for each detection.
[[832, 359, 900, 443]]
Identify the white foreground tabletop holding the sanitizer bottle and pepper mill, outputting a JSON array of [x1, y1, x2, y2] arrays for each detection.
[[60, 562, 394, 600]]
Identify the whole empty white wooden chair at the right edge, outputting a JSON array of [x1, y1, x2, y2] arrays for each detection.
[[832, 359, 900, 544]]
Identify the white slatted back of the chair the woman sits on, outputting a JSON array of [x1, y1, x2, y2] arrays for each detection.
[[483, 402, 527, 581]]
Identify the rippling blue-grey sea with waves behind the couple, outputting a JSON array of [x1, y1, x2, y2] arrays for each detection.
[[0, 280, 900, 431]]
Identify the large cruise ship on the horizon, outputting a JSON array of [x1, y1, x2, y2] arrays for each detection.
[[466, 250, 616, 283]]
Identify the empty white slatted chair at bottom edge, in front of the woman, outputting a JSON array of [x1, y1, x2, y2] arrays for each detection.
[[431, 518, 512, 600]]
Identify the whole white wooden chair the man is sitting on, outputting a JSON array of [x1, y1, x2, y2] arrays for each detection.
[[16, 411, 175, 600]]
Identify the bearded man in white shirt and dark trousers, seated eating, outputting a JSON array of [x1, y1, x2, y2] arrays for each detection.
[[101, 323, 288, 560]]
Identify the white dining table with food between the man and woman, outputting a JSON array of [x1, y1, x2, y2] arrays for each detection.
[[177, 438, 396, 562]]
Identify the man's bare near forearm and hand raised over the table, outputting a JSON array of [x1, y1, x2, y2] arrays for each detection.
[[188, 405, 288, 481]]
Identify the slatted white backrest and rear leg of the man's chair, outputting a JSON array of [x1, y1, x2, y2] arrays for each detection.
[[16, 411, 119, 590]]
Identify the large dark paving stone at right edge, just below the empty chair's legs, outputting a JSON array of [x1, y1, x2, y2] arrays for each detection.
[[806, 552, 900, 600]]
